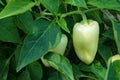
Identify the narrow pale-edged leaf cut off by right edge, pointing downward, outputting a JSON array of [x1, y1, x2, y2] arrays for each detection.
[[112, 21, 120, 54]]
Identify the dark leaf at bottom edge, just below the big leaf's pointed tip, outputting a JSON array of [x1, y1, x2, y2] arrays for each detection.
[[17, 69, 32, 80]]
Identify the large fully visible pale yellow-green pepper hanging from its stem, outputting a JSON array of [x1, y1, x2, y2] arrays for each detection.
[[73, 20, 99, 64]]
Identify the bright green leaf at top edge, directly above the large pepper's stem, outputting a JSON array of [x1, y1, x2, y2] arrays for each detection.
[[65, 0, 87, 8]]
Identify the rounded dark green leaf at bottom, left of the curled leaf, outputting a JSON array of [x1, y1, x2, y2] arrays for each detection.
[[27, 62, 42, 80]]
